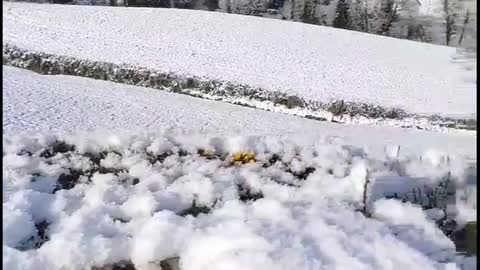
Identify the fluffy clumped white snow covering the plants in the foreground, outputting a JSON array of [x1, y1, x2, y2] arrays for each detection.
[[3, 131, 476, 270]]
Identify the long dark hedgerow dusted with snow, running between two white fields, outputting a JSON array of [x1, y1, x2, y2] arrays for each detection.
[[3, 44, 476, 129]]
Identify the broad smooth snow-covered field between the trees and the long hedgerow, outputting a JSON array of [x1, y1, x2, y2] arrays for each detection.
[[3, 2, 476, 117]]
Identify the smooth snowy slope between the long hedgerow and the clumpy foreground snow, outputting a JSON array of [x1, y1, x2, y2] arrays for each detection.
[[3, 66, 476, 159]]
